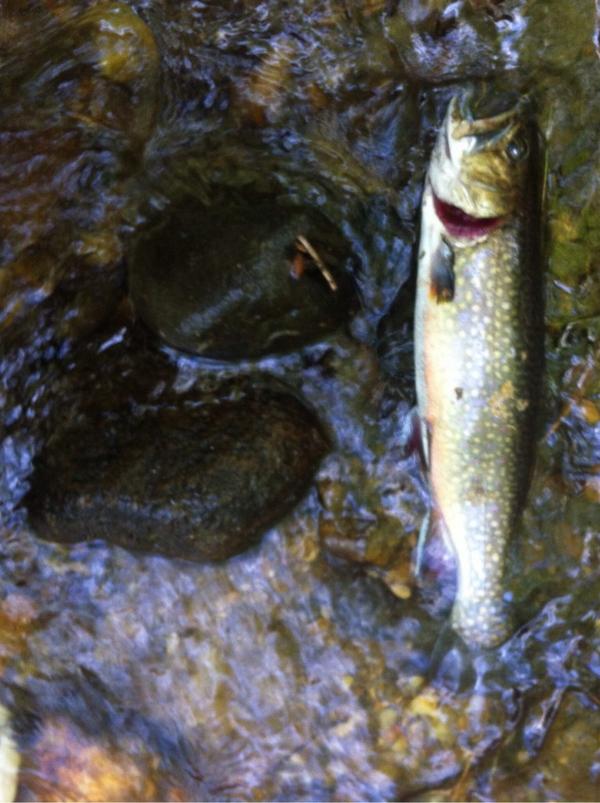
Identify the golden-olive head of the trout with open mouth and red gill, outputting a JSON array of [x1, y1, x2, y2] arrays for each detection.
[[429, 92, 533, 239]]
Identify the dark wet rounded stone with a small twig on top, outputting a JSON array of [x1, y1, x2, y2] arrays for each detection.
[[129, 196, 357, 359]]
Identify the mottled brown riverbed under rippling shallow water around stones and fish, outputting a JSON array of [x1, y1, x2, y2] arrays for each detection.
[[0, 0, 600, 801]]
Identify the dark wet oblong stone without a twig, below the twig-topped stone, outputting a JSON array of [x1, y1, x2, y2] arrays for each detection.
[[25, 385, 328, 561]]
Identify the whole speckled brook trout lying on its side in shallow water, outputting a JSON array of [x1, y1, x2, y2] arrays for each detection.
[[415, 95, 543, 647]]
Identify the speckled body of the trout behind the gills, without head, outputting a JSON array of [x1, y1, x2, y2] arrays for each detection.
[[415, 184, 539, 646]]
